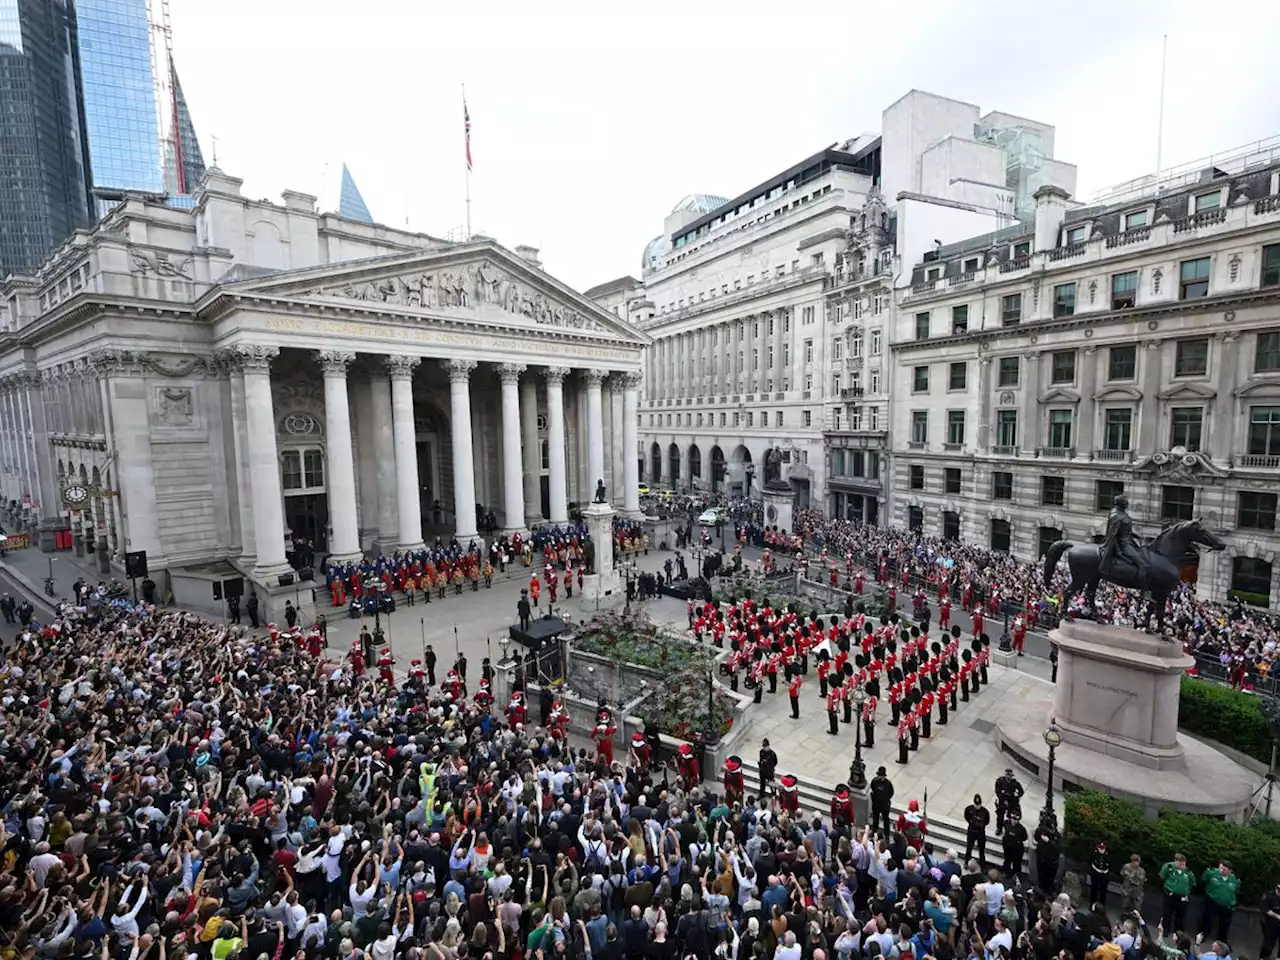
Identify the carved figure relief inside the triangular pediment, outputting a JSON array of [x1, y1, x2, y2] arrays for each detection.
[[319, 260, 604, 330]]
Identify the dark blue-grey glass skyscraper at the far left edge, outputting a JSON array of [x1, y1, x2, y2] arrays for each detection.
[[0, 0, 92, 279]]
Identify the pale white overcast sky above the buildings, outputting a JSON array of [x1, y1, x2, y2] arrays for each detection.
[[170, 0, 1280, 289]]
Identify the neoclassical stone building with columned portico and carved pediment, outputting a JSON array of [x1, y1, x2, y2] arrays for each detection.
[[0, 169, 649, 616]]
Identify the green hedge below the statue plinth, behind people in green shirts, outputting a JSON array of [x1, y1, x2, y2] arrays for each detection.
[[1065, 791, 1280, 905]]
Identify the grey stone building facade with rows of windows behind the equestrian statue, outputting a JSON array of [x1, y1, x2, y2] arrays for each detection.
[[890, 163, 1280, 607]]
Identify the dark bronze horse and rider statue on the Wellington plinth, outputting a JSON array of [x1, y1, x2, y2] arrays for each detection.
[[1044, 494, 1226, 632]]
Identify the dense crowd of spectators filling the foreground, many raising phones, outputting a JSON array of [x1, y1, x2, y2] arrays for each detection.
[[0, 586, 1275, 960]]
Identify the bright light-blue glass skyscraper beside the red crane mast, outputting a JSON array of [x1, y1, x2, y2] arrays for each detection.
[[76, 0, 164, 195]]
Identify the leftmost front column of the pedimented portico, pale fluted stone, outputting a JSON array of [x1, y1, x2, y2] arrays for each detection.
[[238, 343, 289, 582]]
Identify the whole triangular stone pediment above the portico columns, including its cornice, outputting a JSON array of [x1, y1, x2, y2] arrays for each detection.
[[202, 241, 649, 346]]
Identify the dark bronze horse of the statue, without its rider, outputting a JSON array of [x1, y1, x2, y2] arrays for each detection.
[[1044, 520, 1226, 632]]
